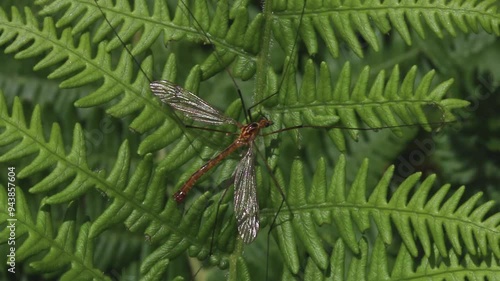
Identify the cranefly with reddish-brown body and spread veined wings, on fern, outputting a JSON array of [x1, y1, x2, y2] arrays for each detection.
[[150, 80, 273, 243]]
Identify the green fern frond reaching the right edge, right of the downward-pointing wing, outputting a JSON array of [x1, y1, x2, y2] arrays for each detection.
[[262, 154, 500, 274]]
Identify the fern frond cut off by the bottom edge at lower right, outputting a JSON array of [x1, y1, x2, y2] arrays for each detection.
[[281, 237, 500, 281]]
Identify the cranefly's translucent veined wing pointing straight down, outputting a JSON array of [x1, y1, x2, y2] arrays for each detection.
[[234, 143, 259, 244]]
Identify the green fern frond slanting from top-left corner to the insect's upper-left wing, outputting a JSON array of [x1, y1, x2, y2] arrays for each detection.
[[0, 4, 189, 151]]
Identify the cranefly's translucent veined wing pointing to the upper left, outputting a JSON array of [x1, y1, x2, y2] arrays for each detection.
[[149, 80, 238, 125]]
